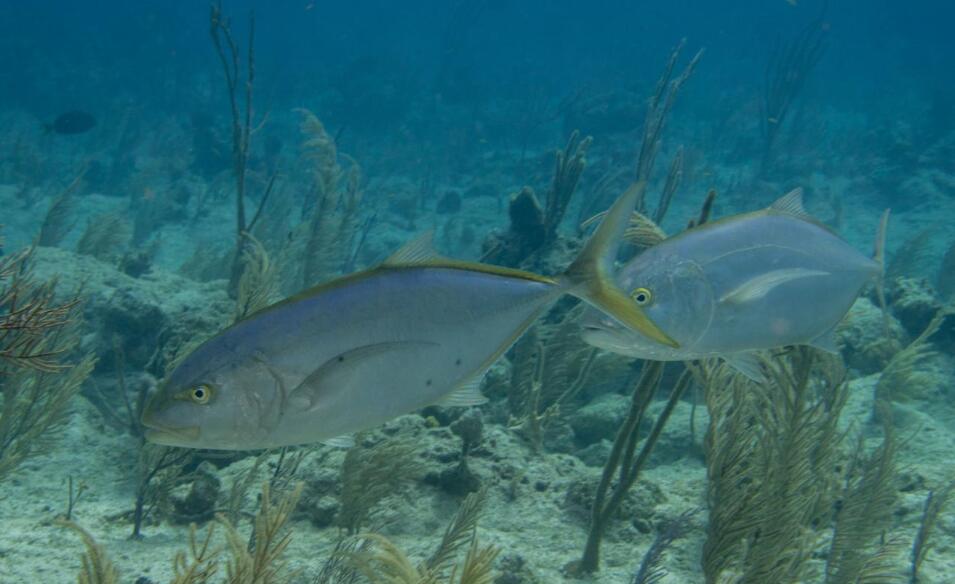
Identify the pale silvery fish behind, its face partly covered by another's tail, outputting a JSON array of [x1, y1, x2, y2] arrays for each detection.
[[581, 189, 888, 381]]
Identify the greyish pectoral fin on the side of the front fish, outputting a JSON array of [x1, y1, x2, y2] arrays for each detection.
[[290, 341, 437, 410]]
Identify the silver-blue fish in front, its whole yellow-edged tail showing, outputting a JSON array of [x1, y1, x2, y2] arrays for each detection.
[[141, 184, 672, 450]]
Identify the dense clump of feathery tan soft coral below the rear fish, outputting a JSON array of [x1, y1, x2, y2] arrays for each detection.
[[696, 348, 900, 584]]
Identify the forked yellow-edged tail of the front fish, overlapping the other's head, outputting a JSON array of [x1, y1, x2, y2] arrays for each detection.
[[563, 181, 679, 347]]
